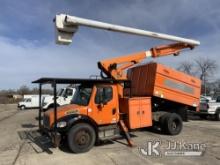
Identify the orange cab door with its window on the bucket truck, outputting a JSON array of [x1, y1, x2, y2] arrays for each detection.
[[92, 85, 119, 125]]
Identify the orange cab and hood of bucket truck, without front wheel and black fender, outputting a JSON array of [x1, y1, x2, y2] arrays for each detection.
[[44, 84, 119, 128]]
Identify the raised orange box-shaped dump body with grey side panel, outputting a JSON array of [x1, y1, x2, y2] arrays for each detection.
[[128, 63, 201, 107]]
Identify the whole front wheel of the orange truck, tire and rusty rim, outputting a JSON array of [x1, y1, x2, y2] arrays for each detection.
[[68, 123, 96, 153]]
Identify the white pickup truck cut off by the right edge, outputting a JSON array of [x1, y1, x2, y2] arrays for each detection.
[[194, 96, 220, 121]]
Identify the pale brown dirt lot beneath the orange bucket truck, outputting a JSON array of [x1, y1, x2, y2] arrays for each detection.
[[0, 105, 220, 165]]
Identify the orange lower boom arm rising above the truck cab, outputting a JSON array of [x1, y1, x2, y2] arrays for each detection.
[[98, 43, 194, 80]]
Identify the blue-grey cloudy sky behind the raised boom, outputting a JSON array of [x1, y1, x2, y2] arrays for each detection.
[[0, 0, 220, 89]]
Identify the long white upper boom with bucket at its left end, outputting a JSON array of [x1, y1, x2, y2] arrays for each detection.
[[55, 14, 200, 46]]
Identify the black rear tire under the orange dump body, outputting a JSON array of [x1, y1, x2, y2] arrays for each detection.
[[163, 113, 183, 135]]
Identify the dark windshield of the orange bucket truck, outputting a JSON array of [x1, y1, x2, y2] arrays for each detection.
[[71, 86, 92, 106]]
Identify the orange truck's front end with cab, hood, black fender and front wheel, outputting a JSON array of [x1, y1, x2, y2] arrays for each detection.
[[43, 81, 120, 153]]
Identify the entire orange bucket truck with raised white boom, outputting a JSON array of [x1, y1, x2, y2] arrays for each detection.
[[33, 15, 201, 153]]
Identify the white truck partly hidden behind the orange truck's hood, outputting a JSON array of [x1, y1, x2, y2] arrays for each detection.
[[42, 87, 76, 111]]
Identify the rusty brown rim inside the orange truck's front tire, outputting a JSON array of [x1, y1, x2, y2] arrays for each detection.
[[74, 130, 91, 148]]
